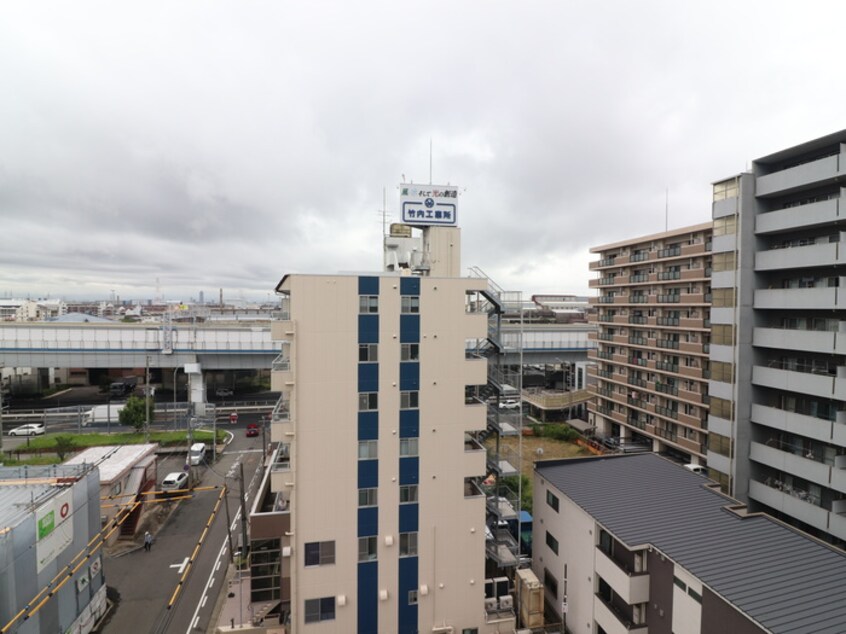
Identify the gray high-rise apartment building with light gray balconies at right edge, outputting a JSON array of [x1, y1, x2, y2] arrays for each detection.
[[707, 130, 846, 546]]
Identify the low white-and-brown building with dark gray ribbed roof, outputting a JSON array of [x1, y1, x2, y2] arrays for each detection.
[[532, 453, 846, 634]]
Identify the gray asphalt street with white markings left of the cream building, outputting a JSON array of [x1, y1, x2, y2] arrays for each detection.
[[103, 415, 263, 634]]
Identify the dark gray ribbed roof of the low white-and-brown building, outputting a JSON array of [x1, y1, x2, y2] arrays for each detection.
[[536, 454, 846, 634]]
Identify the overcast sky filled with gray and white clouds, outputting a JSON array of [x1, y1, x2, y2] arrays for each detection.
[[0, 0, 846, 299]]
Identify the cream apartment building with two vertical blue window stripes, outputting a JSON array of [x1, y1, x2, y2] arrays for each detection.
[[268, 190, 517, 634]]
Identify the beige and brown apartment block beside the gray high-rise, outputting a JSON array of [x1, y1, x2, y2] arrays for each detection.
[[588, 223, 712, 464]]
